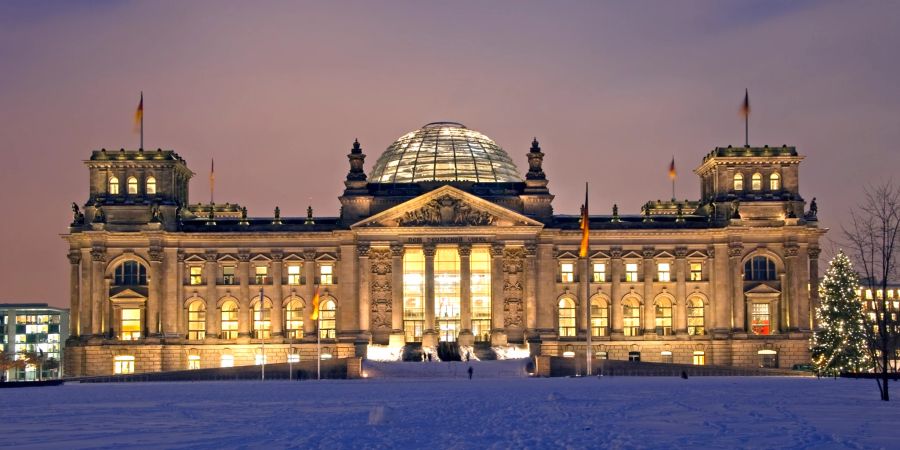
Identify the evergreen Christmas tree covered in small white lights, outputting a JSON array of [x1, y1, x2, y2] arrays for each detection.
[[810, 251, 872, 375]]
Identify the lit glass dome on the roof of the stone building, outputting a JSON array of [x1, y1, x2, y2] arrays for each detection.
[[369, 122, 522, 183]]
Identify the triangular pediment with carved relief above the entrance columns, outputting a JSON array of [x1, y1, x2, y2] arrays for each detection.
[[350, 185, 544, 228]]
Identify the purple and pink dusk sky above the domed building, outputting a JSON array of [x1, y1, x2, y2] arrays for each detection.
[[0, 0, 900, 306]]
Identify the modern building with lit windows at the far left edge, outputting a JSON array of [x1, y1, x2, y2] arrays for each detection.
[[0, 303, 69, 381]]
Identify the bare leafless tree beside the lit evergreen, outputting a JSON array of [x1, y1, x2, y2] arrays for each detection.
[[843, 181, 900, 401]]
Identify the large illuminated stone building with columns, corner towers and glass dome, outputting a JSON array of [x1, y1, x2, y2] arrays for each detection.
[[64, 122, 824, 374]]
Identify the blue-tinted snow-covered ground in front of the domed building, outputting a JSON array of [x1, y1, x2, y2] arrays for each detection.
[[0, 372, 900, 449]]
